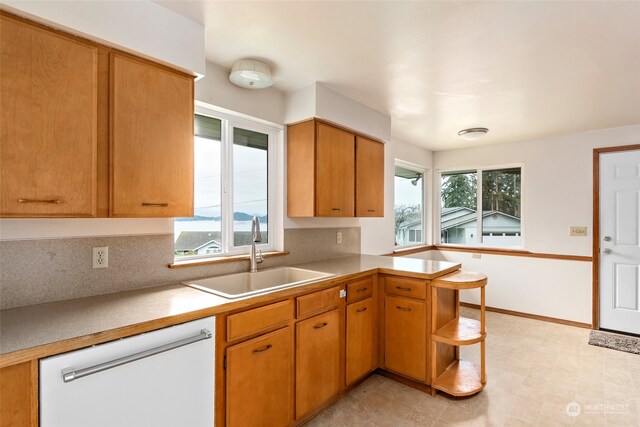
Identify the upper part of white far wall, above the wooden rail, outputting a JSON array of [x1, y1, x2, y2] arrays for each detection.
[[433, 125, 640, 256]]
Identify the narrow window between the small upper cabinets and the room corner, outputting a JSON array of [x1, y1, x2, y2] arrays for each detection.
[[394, 163, 424, 246]]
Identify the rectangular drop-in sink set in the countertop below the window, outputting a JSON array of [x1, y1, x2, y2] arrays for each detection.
[[183, 267, 334, 299]]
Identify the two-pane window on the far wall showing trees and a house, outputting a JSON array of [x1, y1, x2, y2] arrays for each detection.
[[440, 167, 522, 247]]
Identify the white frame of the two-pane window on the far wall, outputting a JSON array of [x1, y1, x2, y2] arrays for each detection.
[[433, 162, 525, 251]]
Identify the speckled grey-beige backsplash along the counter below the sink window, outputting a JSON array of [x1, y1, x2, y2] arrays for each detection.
[[0, 227, 360, 309]]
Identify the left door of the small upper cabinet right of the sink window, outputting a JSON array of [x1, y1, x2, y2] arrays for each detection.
[[316, 123, 355, 216]]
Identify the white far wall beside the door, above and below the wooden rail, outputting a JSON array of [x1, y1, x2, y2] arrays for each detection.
[[423, 125, 640, 323]]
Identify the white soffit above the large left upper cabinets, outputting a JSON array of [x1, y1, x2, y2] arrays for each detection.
[[1, 0, 205, 75]]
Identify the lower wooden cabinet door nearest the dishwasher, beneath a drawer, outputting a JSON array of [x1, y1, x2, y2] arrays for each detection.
[[227, 327, 293, 427]]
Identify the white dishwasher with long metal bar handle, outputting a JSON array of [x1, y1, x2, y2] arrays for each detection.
[[40, 317, 215, 427]]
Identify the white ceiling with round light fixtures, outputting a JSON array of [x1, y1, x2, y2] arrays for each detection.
[[158, 0, 640, 150]]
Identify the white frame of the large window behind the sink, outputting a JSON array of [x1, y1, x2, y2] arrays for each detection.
[[174, 105, 284, 262]]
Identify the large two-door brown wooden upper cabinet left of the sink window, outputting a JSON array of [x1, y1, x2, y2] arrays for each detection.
[[0, 12, 194, 218]]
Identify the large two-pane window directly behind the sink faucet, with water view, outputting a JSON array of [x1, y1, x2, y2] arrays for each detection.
[[174, 107, 279, 259]]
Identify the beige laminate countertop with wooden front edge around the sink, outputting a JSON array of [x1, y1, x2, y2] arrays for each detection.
[[0, 255, 460, 367]]
